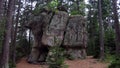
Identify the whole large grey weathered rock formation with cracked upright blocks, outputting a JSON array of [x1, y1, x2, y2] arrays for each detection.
[[26, 8, 87, 63]]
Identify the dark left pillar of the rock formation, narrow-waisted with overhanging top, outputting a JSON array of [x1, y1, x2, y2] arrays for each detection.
[[27, 12, 52, 63]]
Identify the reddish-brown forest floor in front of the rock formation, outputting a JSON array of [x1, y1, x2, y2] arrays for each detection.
[[16, 56, 109, 68]]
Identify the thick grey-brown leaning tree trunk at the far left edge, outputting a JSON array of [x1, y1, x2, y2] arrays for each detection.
[[0, 0, 14, 68]]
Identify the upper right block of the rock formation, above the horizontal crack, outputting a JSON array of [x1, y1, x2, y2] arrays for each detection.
[[63, 15, 87, 47]]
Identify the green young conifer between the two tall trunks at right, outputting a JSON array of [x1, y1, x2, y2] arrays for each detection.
[[104, 28, 116, 63]]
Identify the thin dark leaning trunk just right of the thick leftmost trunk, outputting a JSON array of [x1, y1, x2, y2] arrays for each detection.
[[11, 0, 21, 64]]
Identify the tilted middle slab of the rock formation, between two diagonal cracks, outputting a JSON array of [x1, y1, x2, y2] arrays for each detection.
[[42, 11, 69, 46]]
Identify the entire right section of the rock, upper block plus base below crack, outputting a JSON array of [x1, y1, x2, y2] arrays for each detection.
[[63, 15, 87, 59]]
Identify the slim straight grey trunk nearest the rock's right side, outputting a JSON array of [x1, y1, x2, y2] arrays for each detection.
[[98, 0, 104, 60]]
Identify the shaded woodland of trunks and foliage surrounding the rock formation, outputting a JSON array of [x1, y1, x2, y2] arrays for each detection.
[[0, 0, 120, 68]]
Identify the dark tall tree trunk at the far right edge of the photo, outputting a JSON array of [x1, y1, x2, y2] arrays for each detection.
[[112, 0, 120, 55]]
